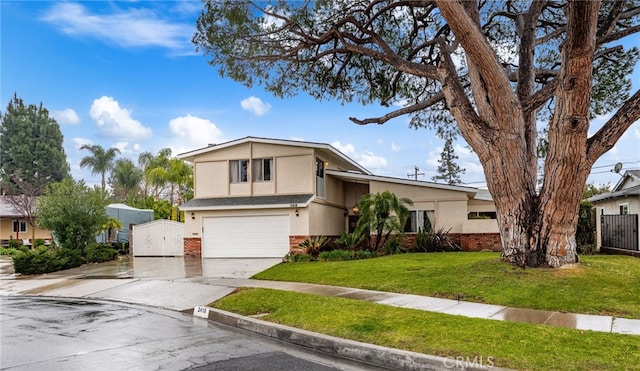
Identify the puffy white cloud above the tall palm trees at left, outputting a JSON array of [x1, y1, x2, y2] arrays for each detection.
[[89, 96, 153, 140]]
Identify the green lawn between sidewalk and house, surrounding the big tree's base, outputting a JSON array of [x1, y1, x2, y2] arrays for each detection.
[[254, 253, 640, 318]]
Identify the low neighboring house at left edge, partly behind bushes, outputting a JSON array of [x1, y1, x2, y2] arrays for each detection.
[[0, 196, 51, 245]]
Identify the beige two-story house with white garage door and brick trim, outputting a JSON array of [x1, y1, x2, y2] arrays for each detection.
[[178, 137, 501, 258]]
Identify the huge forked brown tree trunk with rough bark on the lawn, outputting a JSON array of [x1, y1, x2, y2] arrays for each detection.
[[437, 0, 600, 267]]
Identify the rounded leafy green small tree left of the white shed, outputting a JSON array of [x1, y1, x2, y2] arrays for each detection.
[[38, 178, 108, 255]]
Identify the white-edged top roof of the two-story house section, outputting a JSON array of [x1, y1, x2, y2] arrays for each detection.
[[177, 137, 371, 174]]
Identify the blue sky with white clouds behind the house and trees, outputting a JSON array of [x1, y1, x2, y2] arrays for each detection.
[[0, 0, 640, 190]]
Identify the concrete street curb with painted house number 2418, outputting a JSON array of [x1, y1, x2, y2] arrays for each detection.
[[183, 306, 508, 371]]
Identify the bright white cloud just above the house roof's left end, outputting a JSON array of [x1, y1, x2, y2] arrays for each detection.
[[169, 115, 225, 154]]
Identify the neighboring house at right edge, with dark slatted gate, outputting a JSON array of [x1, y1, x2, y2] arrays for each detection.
[[588, 170, 640, 251]]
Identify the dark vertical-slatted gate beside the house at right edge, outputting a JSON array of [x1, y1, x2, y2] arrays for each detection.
[[601, 214, 638, 251]]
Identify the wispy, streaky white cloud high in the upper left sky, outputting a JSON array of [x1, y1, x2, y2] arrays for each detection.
[[43, 2, 193, 54]]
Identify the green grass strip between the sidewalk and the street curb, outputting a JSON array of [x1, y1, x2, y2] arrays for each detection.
[[210, 290, 640, 370]]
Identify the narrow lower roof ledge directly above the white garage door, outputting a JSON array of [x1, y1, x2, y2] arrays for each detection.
[[180, 194, 314, 211]]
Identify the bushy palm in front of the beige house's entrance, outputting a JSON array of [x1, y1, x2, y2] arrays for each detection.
[[356, 191, 413, 251]]
